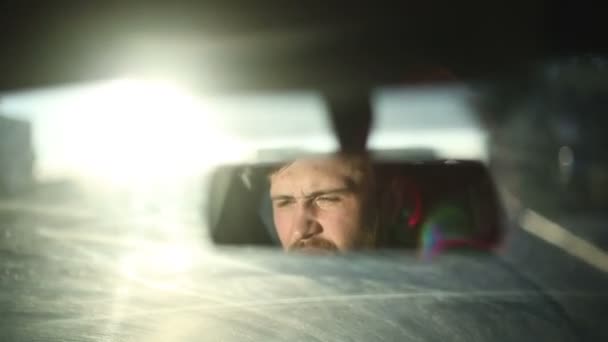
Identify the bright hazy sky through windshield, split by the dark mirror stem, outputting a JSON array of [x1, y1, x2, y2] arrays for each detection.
[[0, 78, 487, 181]]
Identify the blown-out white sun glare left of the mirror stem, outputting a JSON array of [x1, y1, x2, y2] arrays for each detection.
[[54, 79, 243, 184]]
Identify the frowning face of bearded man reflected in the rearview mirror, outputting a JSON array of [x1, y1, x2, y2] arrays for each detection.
[[270, 155, 375, 253]]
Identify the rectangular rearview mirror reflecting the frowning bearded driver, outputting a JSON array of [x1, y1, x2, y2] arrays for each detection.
[[204, 156, 504, 255]]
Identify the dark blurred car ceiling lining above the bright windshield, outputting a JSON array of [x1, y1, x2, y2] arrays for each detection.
[[0, 0, 602, 92]]
